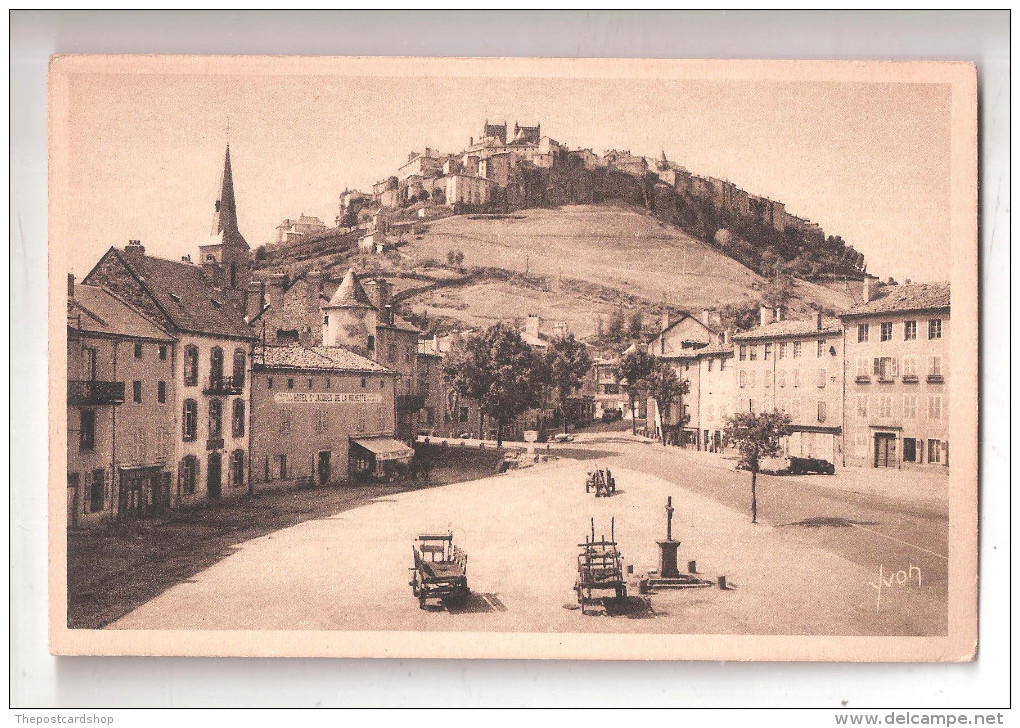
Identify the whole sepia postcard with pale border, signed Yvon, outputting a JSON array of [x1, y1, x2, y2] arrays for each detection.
[[49, 55, 978, 662]]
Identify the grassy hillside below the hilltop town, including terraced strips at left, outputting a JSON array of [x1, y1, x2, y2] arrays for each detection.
[[252, 199, 856, 335]]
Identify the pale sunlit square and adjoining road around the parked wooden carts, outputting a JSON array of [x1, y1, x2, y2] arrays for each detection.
[[111, 437, 947, 635]]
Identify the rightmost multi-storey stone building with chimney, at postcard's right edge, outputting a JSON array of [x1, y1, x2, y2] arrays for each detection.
[[840, 276, 951, 468]]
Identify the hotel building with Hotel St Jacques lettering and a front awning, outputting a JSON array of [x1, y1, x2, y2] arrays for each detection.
[[251, 346, 405, 489]]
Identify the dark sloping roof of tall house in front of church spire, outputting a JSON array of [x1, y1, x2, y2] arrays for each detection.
[[114, 250, 255, 339]]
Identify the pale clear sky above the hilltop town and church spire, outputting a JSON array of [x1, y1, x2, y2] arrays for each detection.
[[59, 72, 951, 282]]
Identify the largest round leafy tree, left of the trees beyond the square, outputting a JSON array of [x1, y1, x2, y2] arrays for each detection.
[[445, 322, 539, 447]]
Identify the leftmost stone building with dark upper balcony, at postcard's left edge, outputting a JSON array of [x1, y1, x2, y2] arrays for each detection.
[[67, 276, 176, 527]]
